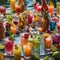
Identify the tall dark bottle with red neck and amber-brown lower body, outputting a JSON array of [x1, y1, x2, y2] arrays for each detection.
[[40, 0, 49, 30]]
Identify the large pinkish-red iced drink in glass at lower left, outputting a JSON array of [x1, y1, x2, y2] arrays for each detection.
[[4, 37, 14, 54]]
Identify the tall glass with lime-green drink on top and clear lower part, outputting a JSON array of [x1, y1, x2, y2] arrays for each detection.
[[28, 35, 42, 60]]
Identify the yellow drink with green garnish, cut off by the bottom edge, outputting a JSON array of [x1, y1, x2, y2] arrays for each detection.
[[13, 45, 22, 60]]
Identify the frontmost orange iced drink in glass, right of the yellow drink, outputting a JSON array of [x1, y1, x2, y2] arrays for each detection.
[[23, 44, 32, 59]]
